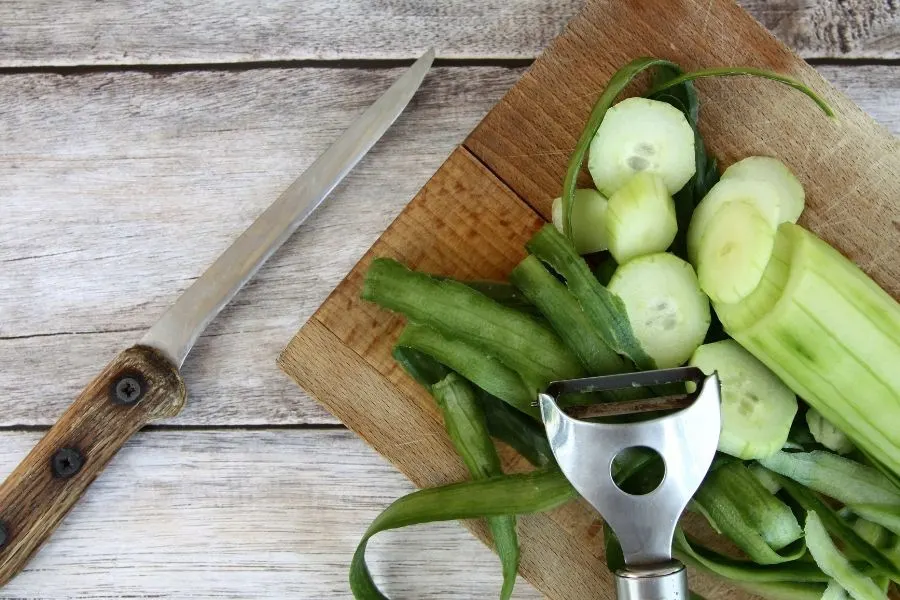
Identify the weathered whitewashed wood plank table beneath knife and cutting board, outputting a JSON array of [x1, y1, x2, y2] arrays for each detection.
[[0, 0, 900, 599]]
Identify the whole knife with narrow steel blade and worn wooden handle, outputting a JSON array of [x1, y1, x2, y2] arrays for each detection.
[[0, 49, 434, 586]]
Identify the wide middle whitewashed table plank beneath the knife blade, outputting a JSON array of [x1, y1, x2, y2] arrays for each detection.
[[0, 66, 900, 427]]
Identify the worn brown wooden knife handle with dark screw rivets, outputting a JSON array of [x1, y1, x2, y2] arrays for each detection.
[[0, 346, 185, 586]]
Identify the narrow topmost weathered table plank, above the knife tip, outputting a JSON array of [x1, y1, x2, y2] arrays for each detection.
[[0, 0, 900, 67]]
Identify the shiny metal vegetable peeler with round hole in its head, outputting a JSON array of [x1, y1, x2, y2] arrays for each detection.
[[538, 367, 721, 600]]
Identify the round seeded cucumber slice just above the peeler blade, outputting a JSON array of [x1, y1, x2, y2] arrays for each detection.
[[608, 252, 710, 369]]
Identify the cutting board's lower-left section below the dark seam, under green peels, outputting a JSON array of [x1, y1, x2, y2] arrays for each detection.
[[279, 149, 744, 599]]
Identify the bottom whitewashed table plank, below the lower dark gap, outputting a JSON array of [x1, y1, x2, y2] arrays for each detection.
[[0, 430, 541, 600]]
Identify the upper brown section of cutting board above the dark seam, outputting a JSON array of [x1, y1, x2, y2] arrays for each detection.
[[466, 0, 900, 297]]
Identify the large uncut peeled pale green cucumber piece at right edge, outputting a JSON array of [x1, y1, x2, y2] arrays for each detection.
[[723, 223, 900, 473]]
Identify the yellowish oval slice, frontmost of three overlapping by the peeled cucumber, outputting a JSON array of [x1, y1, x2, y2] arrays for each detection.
[[695, 200, 777, 304]]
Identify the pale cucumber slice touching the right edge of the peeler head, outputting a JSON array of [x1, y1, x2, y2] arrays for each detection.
[[691, 340, 797, 460]]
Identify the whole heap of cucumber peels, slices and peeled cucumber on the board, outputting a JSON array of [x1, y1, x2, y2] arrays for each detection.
[[350, 58, 900, 600]]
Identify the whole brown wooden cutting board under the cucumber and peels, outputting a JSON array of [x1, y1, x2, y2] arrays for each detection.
[[279, 0, 900, 600]]
